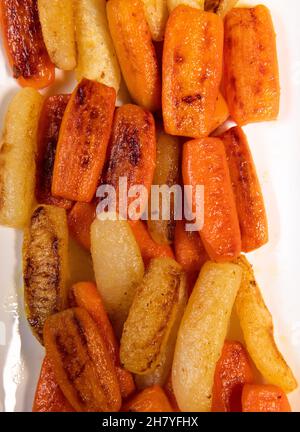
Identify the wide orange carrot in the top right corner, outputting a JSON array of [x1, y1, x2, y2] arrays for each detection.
[[224, 5, 280, 126]]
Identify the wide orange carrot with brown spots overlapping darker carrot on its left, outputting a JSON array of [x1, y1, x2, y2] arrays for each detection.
[[52, 79, 116, 202]]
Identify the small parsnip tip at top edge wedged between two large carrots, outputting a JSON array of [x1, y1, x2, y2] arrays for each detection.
[[142, 0, 169, 41]]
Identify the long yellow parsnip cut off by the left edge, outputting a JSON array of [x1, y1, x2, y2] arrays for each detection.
[[0, 88, 42, 228]]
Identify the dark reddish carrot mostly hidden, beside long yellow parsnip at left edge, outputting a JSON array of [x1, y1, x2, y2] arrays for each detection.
[[35, 95, 72, 209]]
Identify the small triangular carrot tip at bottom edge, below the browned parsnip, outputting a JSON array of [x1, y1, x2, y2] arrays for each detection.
[[122, 385, 173, 412]]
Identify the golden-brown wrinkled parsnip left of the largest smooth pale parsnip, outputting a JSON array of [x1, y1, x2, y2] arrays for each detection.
[[120, 258, 187, 381]]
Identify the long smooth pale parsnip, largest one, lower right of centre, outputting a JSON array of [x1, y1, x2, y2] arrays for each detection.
[[172, 262, 242, 412]]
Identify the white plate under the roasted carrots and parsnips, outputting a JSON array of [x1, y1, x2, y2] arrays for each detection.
[[0, 0, 300, 411]]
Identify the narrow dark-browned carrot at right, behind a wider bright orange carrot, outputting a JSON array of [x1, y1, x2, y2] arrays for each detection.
[[220, 127, 268, 252]]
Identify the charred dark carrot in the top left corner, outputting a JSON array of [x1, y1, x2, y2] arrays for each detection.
[[0, 0, 55, 89]]
